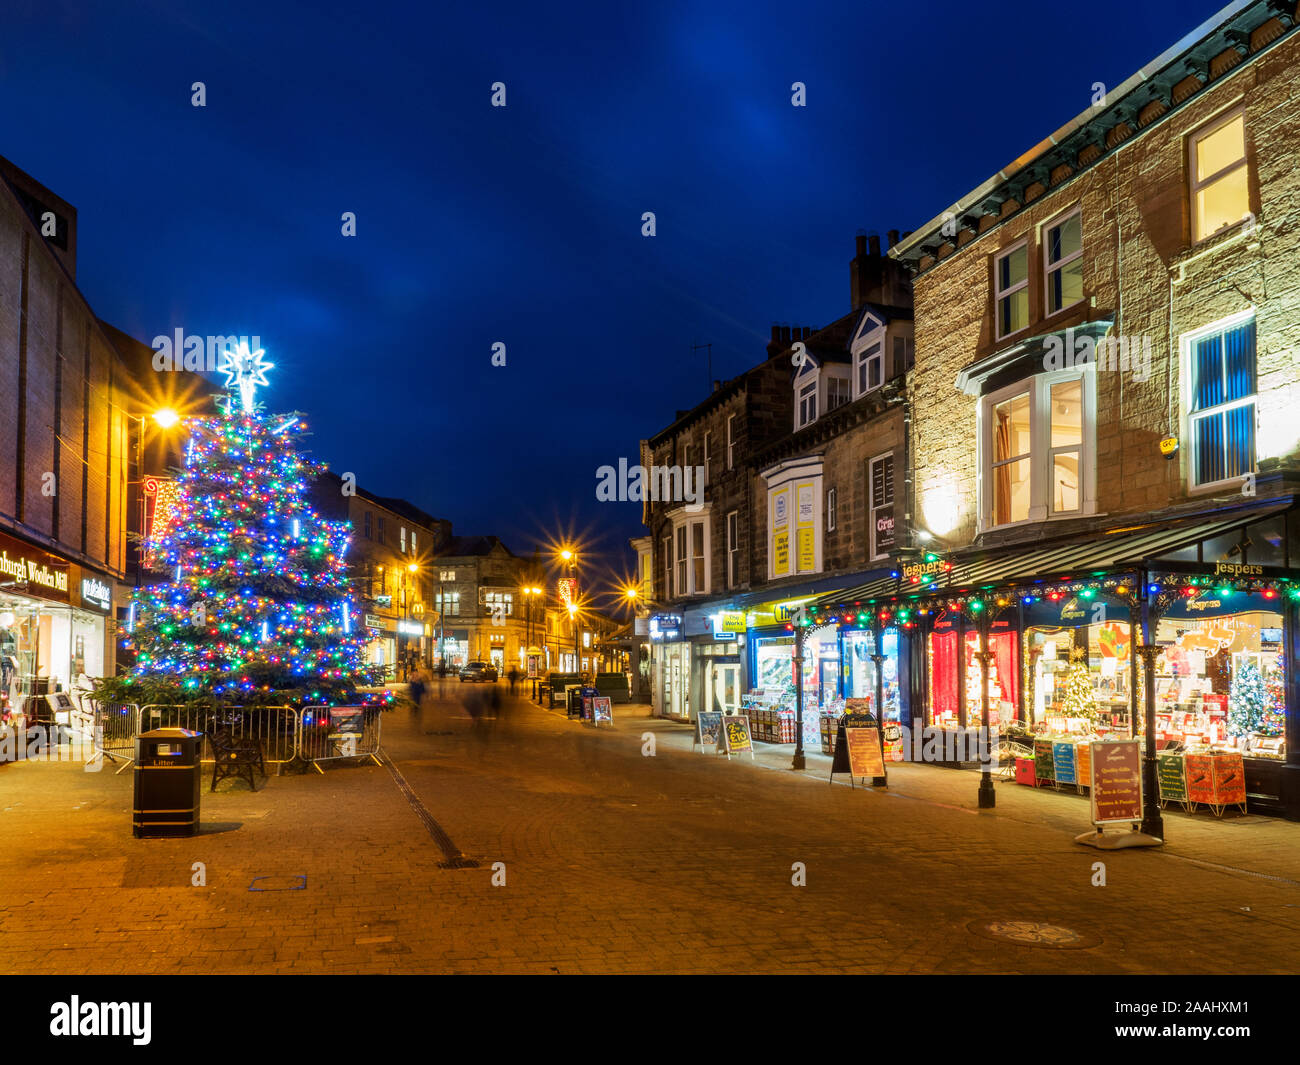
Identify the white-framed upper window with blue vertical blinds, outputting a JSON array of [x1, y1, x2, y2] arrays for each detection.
[[1182, 309, 1258, 489]]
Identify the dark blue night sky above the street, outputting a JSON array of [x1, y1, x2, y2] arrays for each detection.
[[0, 0, 1222, 582]]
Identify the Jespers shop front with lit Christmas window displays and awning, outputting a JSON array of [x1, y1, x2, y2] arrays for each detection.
[[806, 501, 1300, 819]]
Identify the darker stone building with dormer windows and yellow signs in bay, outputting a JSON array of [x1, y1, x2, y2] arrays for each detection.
[[638, 234, 913, 718]]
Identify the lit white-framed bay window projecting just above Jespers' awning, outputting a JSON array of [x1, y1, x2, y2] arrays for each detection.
[[979, 367, 1096, 528]]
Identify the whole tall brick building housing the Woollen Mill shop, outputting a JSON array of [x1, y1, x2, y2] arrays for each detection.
[[0, 159, 192, 715]]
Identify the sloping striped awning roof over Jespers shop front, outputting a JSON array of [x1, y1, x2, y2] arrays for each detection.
[[810, 499, 1300, 611]]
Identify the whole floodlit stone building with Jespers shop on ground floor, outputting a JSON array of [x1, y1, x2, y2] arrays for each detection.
[[816, 0, 1300, 817]]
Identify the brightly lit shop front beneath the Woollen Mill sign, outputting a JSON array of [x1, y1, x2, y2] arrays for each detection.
[[0, 534, 113, 720]]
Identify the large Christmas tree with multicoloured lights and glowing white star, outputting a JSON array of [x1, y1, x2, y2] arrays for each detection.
[[125, 345, 372, 703]]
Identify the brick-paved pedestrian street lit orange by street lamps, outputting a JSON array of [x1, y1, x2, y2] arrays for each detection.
[[0, 690, 1300, 974]]
